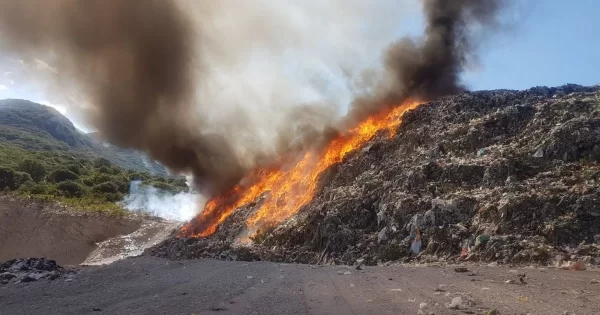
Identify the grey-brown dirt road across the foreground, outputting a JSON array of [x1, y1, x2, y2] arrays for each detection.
[[0, 257, 600, 315]]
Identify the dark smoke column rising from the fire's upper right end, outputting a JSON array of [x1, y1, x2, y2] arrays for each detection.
[[346, 0, 509, 125]]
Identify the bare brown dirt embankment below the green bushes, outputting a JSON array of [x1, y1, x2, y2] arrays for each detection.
[[0, 196, 146, 265]]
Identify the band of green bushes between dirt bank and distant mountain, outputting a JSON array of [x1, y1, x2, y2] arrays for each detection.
[[0, 142, 188, 212]]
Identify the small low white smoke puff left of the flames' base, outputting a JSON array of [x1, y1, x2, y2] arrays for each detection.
[[121, 181, 205, 222]]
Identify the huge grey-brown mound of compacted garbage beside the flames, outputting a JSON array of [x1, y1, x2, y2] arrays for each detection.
[[147, 85, 600, 265]]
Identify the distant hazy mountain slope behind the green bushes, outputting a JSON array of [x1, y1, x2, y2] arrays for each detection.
[[0, 99, 166, 175]]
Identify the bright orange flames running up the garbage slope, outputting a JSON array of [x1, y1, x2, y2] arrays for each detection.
[[181, 102, 420, 237]]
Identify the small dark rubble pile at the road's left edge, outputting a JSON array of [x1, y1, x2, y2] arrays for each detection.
[[0, 258, 75, 285]]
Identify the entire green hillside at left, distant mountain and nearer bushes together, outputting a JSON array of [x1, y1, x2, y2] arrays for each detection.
[[0, 100, 188, 213]]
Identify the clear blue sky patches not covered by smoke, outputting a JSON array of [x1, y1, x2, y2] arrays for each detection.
[[0, 0, 600, 130]]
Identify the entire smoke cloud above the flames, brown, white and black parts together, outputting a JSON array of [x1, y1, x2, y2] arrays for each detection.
[[0, 0, 502, 198]]
